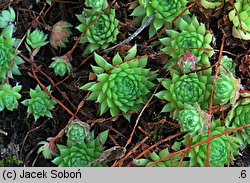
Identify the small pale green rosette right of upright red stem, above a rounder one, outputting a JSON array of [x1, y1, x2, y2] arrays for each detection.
[[220, 55, 236, 75]]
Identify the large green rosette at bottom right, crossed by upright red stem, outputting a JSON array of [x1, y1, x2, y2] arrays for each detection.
[[183, 121, 239, 167]]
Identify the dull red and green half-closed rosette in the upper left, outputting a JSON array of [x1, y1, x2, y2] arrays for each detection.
[[49, 21, 72, 49]]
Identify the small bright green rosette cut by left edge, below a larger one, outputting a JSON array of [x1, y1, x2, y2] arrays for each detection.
[[0, 83, 22, 111]]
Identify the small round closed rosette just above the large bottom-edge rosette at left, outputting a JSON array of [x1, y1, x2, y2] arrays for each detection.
[[67, 120, 90, 143]]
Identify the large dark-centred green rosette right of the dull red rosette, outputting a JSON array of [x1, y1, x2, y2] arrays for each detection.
[[76, 9, 119, 55]]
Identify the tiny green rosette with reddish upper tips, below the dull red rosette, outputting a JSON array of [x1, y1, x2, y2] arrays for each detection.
[[49, 56, 72, 76]]
